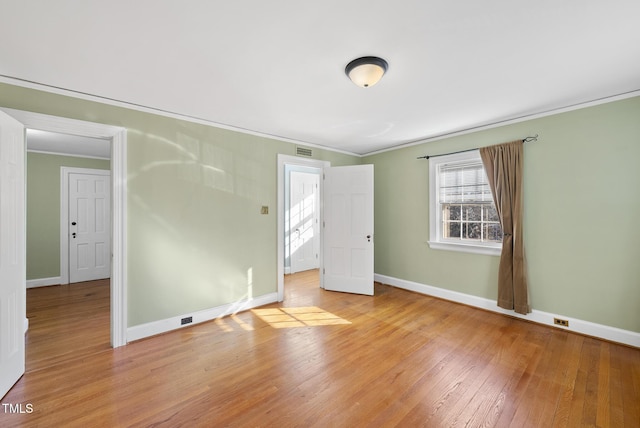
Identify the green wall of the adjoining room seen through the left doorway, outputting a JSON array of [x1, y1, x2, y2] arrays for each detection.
[[27, 152, 110, 280]]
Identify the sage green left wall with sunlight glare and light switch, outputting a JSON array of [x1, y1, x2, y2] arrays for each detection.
[[0, 84, 360, 326]]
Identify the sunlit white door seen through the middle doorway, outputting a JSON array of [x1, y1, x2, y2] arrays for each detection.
[[289, 171, 320, 273]]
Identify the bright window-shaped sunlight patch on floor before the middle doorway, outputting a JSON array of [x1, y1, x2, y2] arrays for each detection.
[[252, 306, 351, 328]]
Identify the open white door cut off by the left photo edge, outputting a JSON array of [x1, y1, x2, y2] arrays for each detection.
[[0, 112, 27, 398]]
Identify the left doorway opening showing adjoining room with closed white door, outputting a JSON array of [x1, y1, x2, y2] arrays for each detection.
[[25, 136, 111, 372]]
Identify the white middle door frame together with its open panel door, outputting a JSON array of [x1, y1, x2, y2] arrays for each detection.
[[277, 155, 374, 302]]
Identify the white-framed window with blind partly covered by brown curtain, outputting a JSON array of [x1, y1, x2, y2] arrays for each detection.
[[429, 150, 502, 255]]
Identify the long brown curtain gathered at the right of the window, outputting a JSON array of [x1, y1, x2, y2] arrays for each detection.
[[480, 140, 531, 314]]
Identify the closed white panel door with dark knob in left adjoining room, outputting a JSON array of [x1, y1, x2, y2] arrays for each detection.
[[69, 171, 111, 283]]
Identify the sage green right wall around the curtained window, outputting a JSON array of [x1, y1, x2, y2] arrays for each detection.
[[363, 97, 640, 332]]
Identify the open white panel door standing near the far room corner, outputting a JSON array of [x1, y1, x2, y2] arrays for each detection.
[[323, 165, 373, 295]]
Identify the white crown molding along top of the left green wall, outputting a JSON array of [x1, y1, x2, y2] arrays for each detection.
[[0, 76, 363, 157]]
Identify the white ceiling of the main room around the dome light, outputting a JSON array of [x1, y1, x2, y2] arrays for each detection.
[[0, 0, 640, 154]]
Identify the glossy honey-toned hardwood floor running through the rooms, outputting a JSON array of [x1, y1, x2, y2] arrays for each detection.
[[0, 271, 640, 427]]
